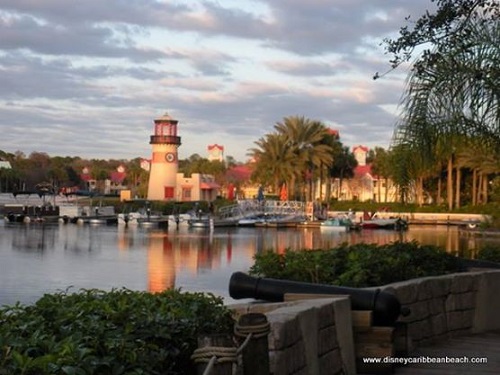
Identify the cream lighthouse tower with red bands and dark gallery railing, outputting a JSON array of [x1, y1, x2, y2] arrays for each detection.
[[148, 113, 181, 200]]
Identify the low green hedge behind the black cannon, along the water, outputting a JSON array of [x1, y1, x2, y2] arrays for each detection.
[[250, 242, 460, 287]]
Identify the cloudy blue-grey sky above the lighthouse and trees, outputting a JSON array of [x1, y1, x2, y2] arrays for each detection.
[[0, 0, 432, 161]]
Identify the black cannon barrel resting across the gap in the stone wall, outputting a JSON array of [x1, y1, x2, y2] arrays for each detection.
[[229, 272, 401, 326]]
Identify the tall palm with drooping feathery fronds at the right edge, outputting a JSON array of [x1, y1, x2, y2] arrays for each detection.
[[394, 20, 500, 209]]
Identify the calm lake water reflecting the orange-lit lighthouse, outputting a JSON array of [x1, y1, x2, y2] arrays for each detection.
[[0, 222, 500, 305]]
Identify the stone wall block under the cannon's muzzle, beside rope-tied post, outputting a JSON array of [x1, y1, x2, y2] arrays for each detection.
[[232, 297, 356, 375]]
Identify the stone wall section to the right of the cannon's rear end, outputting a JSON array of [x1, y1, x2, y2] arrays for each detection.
[[381, 271, 500, 351]]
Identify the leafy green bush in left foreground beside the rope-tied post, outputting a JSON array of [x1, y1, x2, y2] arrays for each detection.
[[0, 289, 233, 375]]
